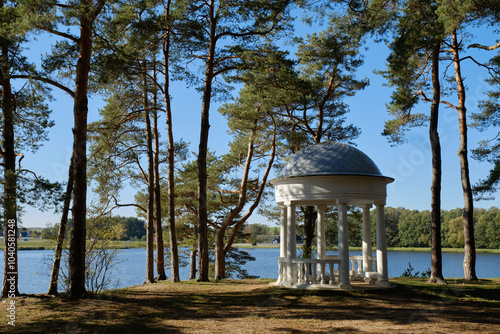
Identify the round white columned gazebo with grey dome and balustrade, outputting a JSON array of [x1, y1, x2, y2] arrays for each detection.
[[271, 142, 394, 289]]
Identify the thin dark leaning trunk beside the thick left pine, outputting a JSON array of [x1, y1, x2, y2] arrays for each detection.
[[47, 151, 75, 295]]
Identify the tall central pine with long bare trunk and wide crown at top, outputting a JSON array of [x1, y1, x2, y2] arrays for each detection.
[[179, 0, 290, 281]]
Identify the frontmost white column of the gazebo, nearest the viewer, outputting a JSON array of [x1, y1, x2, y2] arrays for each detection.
[[338, 200, 351, 289]]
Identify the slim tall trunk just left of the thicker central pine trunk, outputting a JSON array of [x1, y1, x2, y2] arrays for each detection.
[[163, 0, 180, 282]]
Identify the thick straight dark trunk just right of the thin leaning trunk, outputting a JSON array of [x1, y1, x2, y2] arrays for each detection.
[[68, 7, 92, 298]]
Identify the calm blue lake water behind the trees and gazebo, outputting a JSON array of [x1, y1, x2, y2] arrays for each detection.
[[0, 248, 500, 293]]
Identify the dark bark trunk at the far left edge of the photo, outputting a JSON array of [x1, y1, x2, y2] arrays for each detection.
[[0, 32, 19, 298]]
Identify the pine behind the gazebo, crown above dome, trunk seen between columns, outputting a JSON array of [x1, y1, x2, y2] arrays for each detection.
[[274, 18, 368, 256]]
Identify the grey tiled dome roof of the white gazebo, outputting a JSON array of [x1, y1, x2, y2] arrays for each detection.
[[278, 142, 382, 179]]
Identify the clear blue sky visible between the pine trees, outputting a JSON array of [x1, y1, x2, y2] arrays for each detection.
[[17, 19, 498, 227]]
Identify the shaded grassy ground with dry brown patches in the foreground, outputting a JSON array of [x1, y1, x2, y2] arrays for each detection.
[[0, 278, 500, 334]]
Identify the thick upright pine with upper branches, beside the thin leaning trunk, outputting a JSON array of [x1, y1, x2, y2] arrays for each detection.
[[26, 0, 111, 298]]
